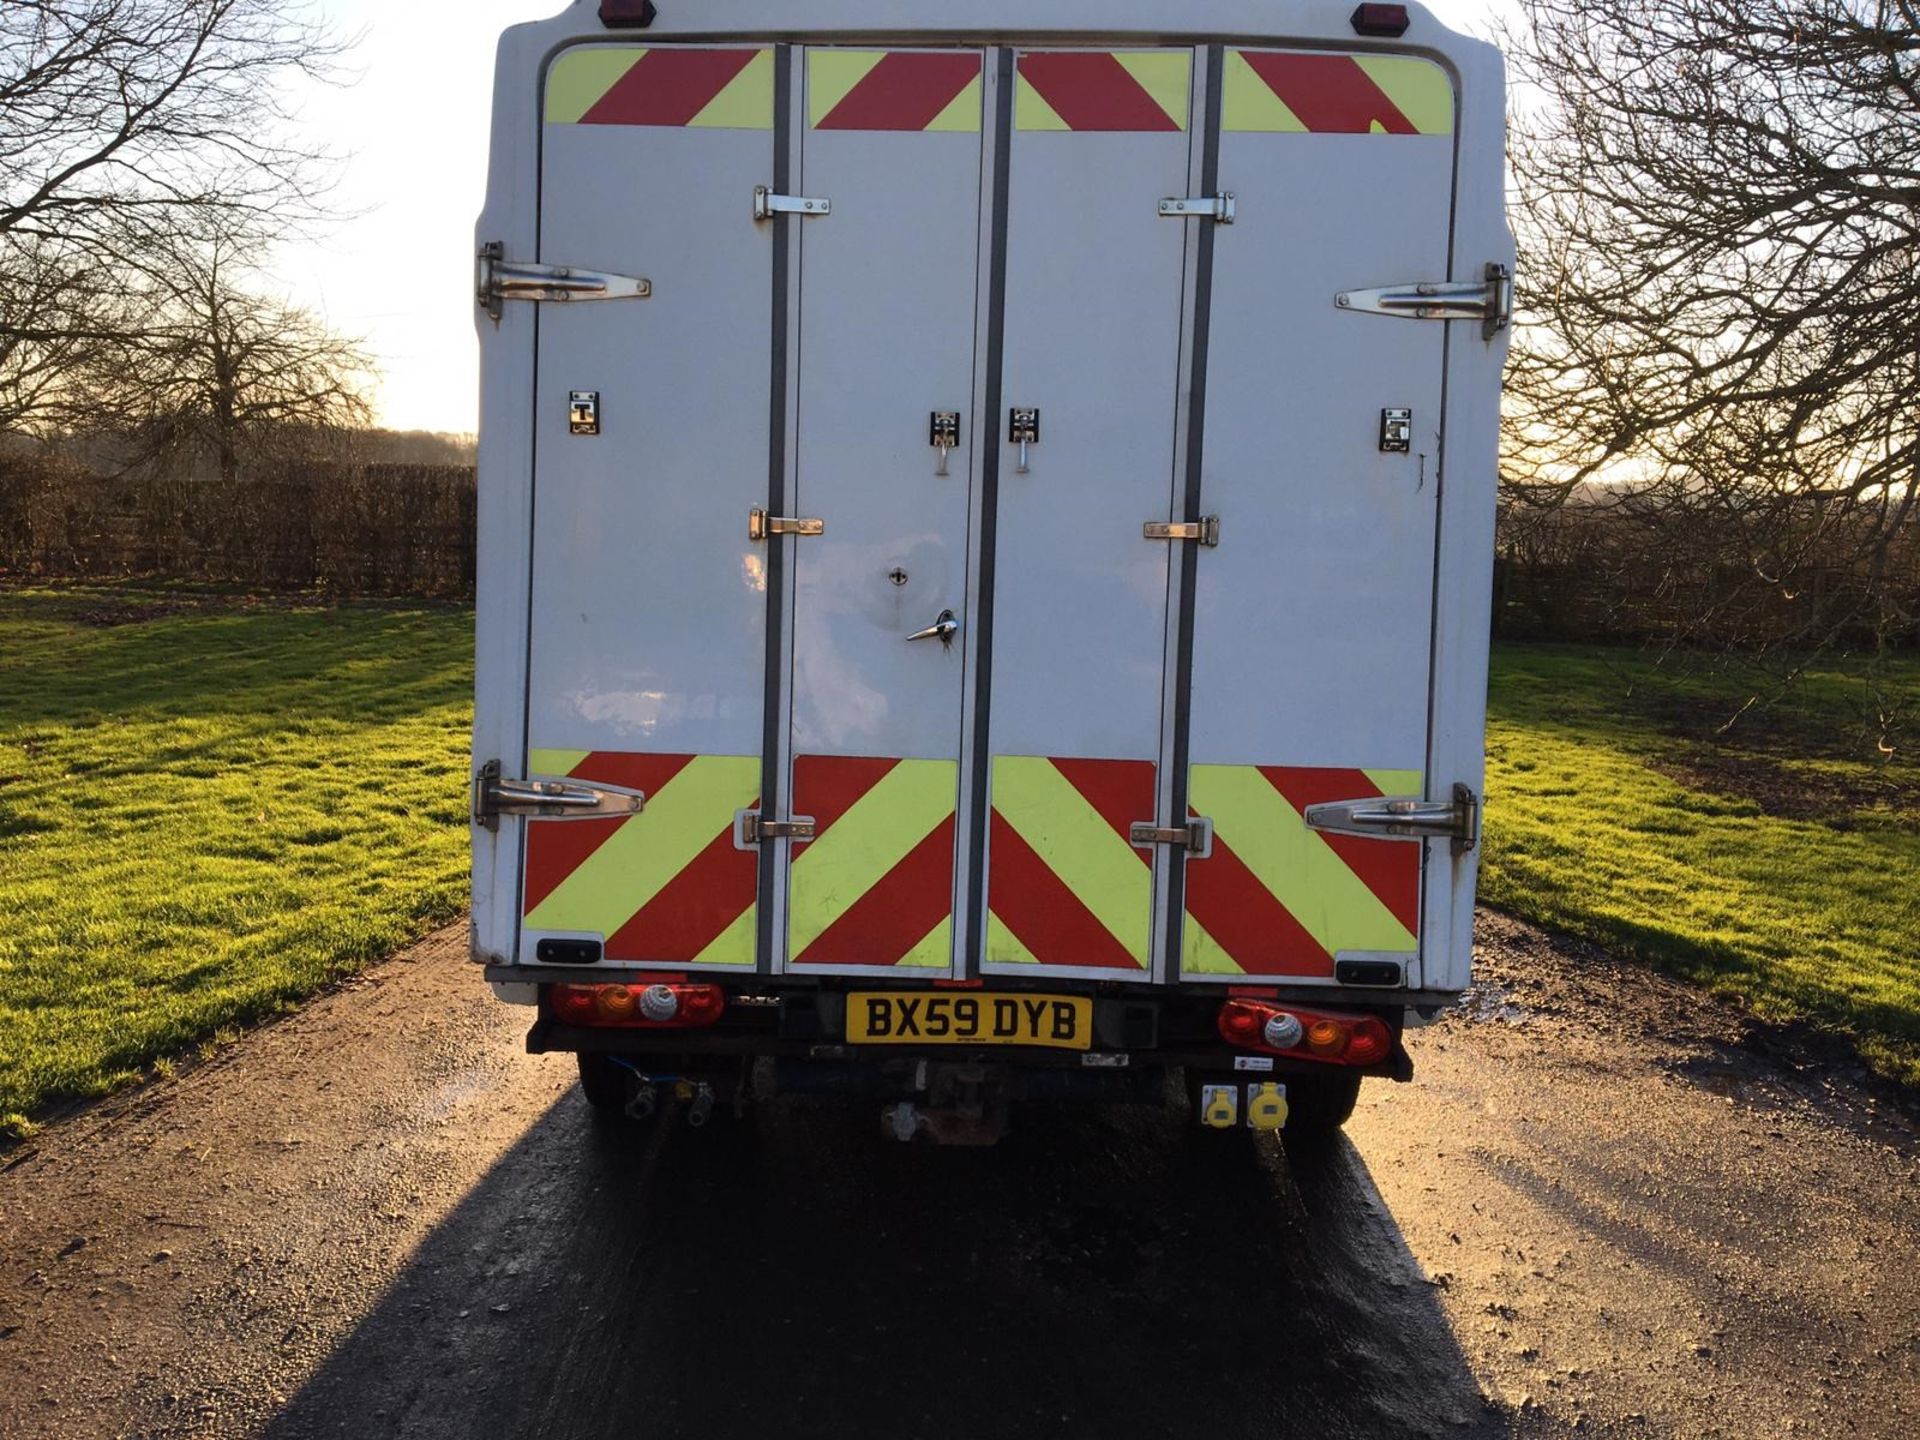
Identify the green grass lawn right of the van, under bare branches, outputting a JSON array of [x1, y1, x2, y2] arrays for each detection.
[[1480, 645, 1920, 1083]]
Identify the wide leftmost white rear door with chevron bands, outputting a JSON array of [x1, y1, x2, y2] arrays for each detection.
[[520, 44, 774, 970]]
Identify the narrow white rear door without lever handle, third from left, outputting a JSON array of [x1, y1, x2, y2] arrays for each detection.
[[983, 50, 1194, 979]]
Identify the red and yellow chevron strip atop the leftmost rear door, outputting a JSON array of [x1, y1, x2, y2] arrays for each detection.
[[547, 44, 774, 131]]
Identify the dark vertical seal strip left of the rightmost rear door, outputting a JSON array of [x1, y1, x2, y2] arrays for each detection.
[[1165, 44, 1227, 981]]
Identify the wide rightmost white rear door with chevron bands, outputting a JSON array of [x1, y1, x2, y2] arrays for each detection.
[[1181, 48, 1457, 983]]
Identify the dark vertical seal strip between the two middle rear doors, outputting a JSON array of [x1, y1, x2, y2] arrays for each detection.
[[956, 48, 1014, 977]]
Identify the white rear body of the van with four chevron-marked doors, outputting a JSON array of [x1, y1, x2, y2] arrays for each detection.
[[474, 0, 1513, 995]]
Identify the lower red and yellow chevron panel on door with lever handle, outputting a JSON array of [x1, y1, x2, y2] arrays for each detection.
[[787, 755, 960, 970]]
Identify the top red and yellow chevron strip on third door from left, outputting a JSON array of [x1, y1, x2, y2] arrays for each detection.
[[1014, 50, 1192, 131]]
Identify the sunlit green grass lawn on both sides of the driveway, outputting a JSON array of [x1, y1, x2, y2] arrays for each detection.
[[0, 586, 1920, 1133]]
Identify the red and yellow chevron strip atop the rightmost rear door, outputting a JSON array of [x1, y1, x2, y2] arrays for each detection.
[[1221, 50, 1453, 134]]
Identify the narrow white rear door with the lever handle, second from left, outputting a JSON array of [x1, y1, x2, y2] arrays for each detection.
[[783, 48, 985, 975]]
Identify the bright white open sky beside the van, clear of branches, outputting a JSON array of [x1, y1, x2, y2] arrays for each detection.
[[275, 0, 1494, 432]]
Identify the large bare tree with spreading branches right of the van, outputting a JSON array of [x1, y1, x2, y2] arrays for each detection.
[[1505, 0, 1920, 664]]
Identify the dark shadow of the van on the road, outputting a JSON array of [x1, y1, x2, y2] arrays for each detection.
[[267, 1092, 1507, 1440]]
